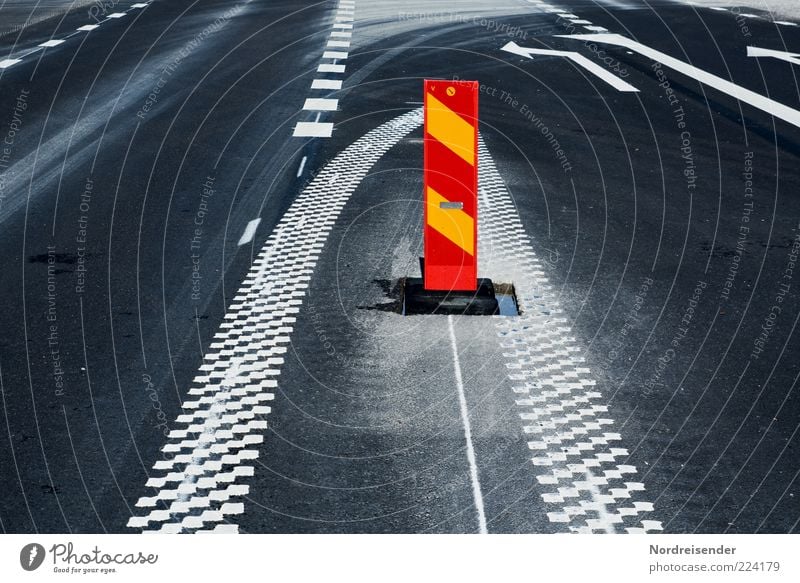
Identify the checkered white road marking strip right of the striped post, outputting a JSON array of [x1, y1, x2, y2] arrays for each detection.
[[478, 136, 662, 533]]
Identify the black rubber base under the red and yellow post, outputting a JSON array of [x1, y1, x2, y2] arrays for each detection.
[[403, 277, 500, 316]]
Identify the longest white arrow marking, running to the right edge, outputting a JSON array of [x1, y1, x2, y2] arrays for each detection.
[[558, 34, 800, 127]]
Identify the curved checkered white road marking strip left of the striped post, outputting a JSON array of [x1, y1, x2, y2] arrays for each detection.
[[128, 109, 422, 532]]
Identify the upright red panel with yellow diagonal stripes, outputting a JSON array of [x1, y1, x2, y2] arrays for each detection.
[[423, 80, 478, 291]]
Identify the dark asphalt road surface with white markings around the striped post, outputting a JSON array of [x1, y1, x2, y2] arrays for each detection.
[[0, 0, 800, 533]]
